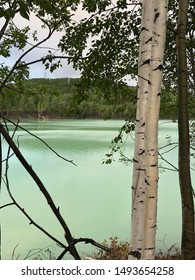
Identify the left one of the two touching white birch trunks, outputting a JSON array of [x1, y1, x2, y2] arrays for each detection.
[[129, 0, 154, 259]]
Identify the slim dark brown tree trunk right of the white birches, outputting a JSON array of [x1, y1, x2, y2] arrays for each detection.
[[177, 0, 195, 259]]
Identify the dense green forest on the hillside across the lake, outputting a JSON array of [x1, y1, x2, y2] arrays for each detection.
[[0, 78, 195, 119]]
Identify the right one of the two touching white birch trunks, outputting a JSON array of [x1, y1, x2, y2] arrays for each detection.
[[142, 0, 168, 259]]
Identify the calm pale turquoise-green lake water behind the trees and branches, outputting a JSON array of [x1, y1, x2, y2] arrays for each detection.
[[0, 120, 189, 259]]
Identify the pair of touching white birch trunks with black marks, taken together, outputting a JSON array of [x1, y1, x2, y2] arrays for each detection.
[[129, 0, 168, 259]]
